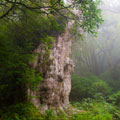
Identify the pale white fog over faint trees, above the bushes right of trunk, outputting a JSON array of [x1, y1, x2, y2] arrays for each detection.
[[72, 0, 120, 90]]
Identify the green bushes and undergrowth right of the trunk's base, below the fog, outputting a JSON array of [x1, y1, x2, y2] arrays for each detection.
[[70, 75, 120, 120]]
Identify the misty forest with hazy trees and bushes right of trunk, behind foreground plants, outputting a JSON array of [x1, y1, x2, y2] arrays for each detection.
[[70, 0, 120, 120]]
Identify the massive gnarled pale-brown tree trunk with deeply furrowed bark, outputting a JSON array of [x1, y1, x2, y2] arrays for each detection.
[[28, 23, 74, 110]]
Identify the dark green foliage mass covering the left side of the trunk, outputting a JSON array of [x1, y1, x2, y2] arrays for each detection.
[[0, 9, 65, 105]]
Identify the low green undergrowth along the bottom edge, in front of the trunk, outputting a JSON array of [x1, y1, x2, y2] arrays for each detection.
[[0, 99, 119, 120]]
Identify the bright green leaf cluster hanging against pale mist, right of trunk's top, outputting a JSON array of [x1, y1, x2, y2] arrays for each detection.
[[75, 0, 103, 35]]
